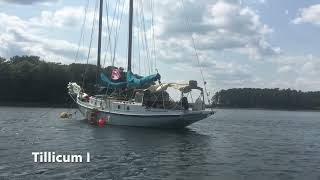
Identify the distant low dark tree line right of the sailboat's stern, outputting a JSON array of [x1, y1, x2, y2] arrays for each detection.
[[212, 88, 320, 110]]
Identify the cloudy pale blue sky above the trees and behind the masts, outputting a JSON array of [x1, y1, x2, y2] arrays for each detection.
[[0, 0, 320, 92]]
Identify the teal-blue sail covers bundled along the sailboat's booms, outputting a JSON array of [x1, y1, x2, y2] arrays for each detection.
[[100, 71, 161, 89]]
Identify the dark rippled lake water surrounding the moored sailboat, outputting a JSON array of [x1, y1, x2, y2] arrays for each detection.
[[0, 107, 320, 180]]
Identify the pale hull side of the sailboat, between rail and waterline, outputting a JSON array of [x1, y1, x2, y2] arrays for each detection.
[[78, 103, 213, 128]]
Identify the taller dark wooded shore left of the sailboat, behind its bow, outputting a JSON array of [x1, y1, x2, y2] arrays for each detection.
[[0, 56, 96, 106]]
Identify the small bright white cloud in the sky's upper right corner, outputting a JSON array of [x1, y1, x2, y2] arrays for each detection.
[[292, 4, 320, 25]]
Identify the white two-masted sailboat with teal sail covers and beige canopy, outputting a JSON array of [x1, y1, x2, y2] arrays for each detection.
[[67, 0, 214, 128]]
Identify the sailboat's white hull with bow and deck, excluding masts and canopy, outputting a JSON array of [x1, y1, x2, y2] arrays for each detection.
[[68, 83, 214, 128]]
